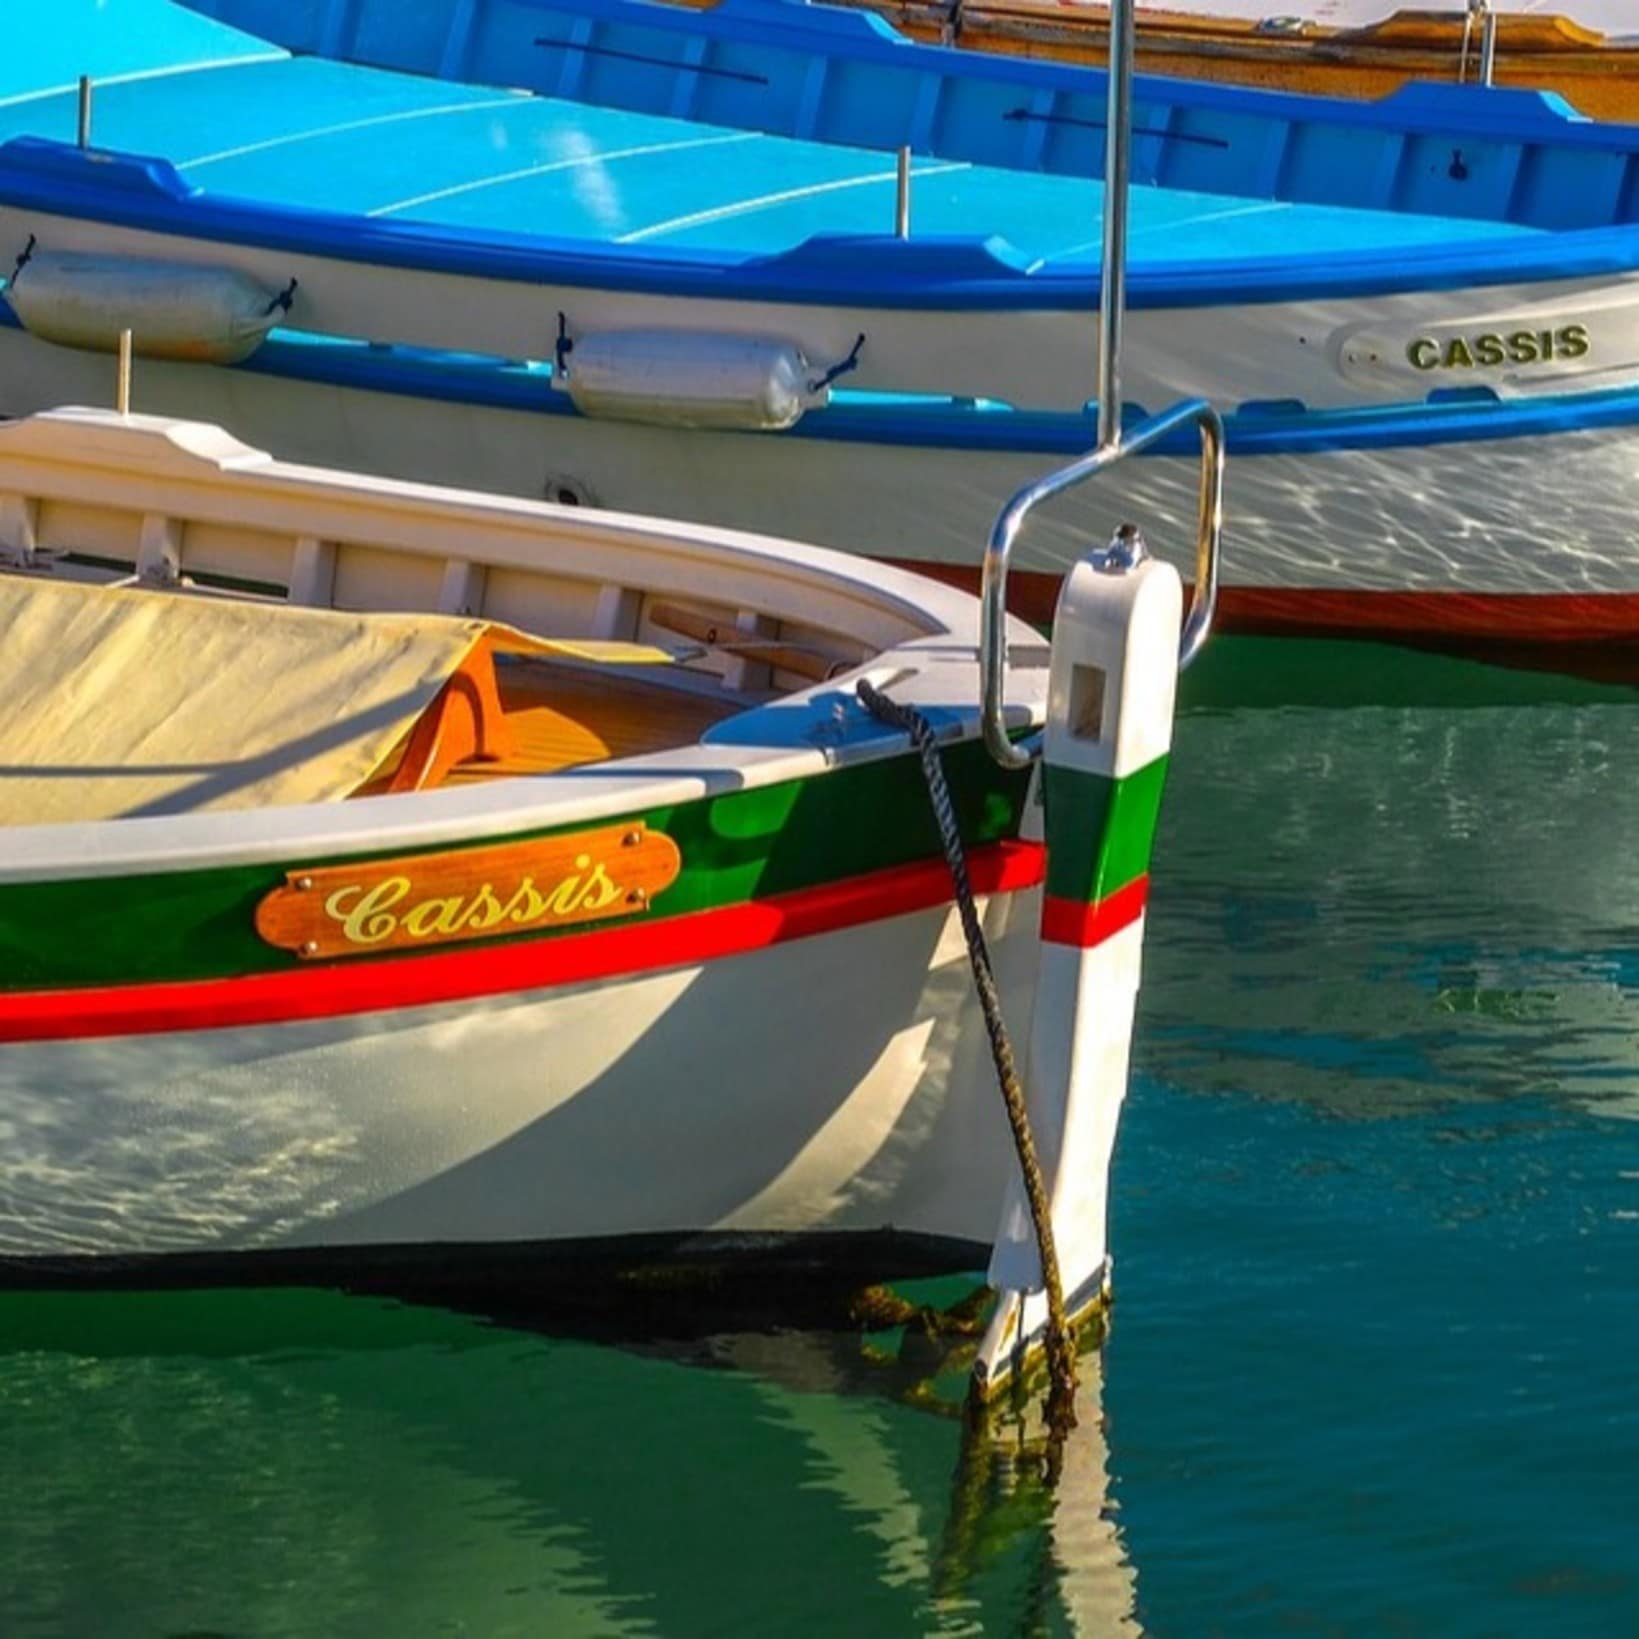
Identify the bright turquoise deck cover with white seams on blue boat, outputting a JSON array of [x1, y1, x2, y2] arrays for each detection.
[[0, 0, 1531, 264]]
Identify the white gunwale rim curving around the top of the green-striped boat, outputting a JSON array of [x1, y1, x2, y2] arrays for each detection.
[[0, 410, 1046, 885]]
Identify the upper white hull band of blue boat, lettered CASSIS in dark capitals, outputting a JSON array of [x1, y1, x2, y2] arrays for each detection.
[[9, 166, 1639, 411]]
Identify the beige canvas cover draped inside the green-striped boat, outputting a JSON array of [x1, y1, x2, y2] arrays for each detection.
[[0, 575, 490, 824]]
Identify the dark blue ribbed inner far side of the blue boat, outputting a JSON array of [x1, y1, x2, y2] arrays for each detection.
[[176, 0, 1639, 242]]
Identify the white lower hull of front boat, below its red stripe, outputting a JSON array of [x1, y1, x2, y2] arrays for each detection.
[[0, 890, 1042, 1270]]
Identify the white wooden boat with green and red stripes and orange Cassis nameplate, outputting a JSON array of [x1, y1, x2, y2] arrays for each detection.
[[0, 380, 1213, 1367]]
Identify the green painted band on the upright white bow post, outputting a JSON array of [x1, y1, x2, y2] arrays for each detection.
[[1042, 756, 1167, 905]]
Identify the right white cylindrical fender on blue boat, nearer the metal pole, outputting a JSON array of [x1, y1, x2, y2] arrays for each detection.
[[565, 329, 829, 433]]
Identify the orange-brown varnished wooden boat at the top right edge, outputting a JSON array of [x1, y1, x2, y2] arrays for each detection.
[[839, 0, 1639, 121]]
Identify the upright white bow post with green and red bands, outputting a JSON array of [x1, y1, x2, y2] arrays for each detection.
[[977, 554, 1183, 1382]]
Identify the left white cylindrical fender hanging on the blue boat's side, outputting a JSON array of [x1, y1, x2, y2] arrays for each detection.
[[5, 239, 297, 364]]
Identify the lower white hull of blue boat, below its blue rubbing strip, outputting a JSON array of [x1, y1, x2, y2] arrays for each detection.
[[0, 331, 1639, 642]]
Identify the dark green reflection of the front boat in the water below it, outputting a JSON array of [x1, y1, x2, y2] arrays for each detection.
[[0, 1290, 1136, 1636]]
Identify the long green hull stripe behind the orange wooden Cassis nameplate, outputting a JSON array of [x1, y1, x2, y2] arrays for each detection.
[[0, 741, 1028, 990]]
